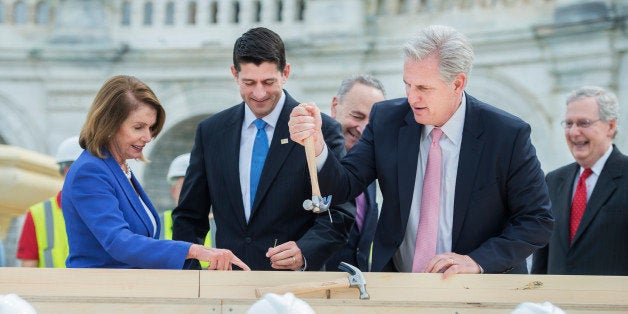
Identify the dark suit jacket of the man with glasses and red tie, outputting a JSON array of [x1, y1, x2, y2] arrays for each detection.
[[532, 145, 628, 275]]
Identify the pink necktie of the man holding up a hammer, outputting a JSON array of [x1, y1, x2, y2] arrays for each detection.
[[412, 128, 443, 273]]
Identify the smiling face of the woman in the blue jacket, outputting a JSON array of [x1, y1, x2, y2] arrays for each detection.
[[109, 103, 157, 164]]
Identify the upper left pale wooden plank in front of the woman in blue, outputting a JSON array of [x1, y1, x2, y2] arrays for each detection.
[[0, 267, 199, 298]]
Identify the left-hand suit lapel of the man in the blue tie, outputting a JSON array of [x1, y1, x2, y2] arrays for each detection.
[[221, 103, 246, 226]]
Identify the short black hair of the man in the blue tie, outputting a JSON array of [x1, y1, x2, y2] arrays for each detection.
[[233, 27, 286, 72]]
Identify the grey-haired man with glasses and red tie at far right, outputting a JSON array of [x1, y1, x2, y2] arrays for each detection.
[[532, 86, 628, 275]]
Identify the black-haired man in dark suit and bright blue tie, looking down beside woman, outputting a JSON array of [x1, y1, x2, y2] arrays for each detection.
[[172, 27, 354, 270]]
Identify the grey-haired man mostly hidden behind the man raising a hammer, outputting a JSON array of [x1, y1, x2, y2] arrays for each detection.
[[325, 74, 386, 271]]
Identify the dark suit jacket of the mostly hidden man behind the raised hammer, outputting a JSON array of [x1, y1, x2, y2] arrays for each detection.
[[325, 182, 379, 272]]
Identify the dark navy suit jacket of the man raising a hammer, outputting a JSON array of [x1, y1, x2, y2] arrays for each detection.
[[319, 94, 553, 273]]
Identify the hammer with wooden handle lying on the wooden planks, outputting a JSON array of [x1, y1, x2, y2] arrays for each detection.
[[255, 262, 370, 300]]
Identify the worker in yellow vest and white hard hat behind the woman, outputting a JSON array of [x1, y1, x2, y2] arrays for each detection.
[[16, 136, 83, 268]]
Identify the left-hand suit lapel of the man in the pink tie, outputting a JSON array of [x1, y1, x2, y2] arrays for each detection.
[[397, 111, 423, 231]]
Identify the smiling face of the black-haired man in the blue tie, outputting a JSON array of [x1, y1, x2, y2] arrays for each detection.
[[231, 62, 290, 118]]
